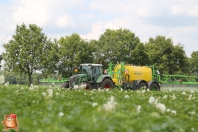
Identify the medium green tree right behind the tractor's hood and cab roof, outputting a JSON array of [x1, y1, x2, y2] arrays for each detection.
[[58, 33, 94, 77]]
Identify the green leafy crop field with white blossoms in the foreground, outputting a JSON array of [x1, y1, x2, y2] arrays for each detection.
[[0, 85, 198, 132]]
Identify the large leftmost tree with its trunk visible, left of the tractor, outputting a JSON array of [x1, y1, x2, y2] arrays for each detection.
[[3, 24, 51, 86]]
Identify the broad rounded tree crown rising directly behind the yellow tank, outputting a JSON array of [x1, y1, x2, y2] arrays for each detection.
[[95, 28, 142, 68]]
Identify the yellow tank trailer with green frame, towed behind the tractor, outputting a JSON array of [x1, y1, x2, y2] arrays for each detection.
[[108, 63, 160, 90]]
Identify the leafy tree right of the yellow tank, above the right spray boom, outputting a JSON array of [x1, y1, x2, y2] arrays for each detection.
[[145, 36, 188, 74]]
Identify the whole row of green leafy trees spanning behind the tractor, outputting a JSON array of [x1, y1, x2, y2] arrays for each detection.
[[0, 24, 198, 85]]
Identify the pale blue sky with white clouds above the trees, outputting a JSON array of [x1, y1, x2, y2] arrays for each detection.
[[0, 0, 198, 57]]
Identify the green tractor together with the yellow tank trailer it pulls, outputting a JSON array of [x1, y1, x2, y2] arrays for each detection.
[[45, 62, 160, 90]]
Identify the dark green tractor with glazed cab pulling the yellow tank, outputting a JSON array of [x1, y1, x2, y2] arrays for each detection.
[[62, 64, 115, 89]]
